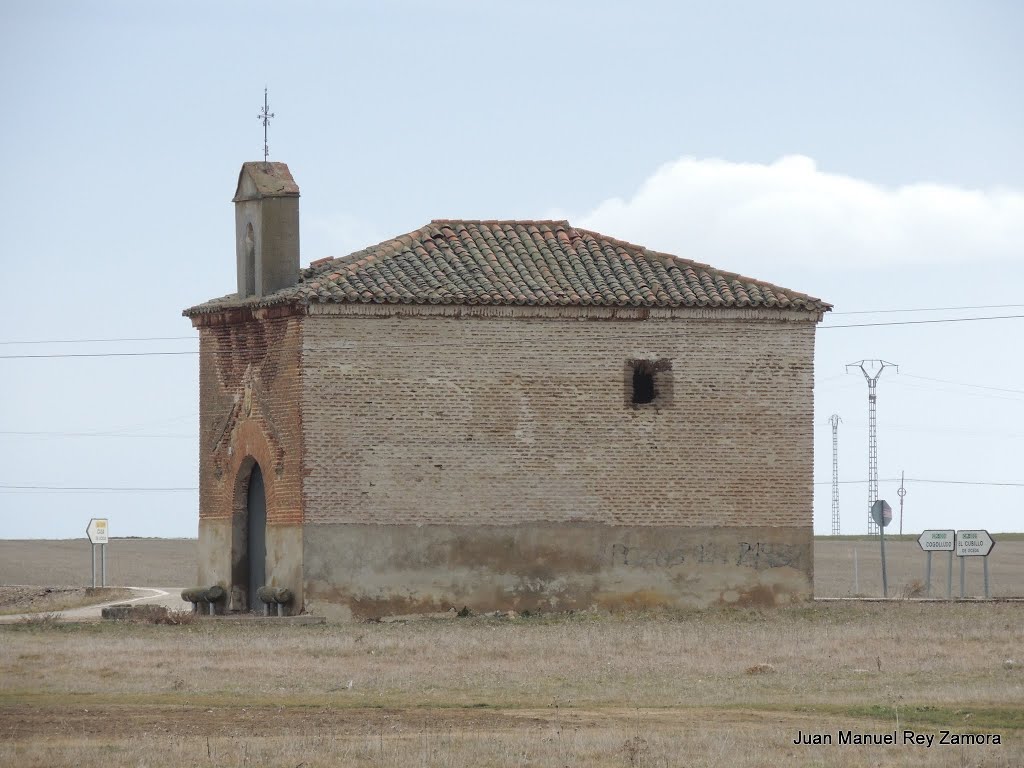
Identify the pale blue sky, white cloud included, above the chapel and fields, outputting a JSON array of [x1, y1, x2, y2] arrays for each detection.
[[0, 0, 1024, 539]]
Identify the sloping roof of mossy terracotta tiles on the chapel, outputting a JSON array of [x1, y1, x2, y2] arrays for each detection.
[[188, 219, 830, 313]]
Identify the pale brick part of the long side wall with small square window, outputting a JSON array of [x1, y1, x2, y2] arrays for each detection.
[[301, 306, 816, 528]]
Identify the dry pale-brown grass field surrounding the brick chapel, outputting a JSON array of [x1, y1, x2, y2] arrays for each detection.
[[0, 540, 1024, 768]]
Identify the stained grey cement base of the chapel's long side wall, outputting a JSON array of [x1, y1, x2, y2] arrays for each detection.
[[303, 523, 813, 618]]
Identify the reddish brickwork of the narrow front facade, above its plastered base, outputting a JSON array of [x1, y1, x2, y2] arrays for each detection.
[[192, 316, 302, 525]]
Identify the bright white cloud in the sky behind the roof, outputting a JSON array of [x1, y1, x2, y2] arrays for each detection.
[[573, 156, 1024, 273]]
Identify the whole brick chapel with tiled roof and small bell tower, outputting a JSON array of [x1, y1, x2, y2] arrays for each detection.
[[184, 162, 830, 617]]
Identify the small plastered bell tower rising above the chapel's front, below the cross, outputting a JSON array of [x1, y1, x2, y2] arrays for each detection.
[[232, 162, 299, 299]]
